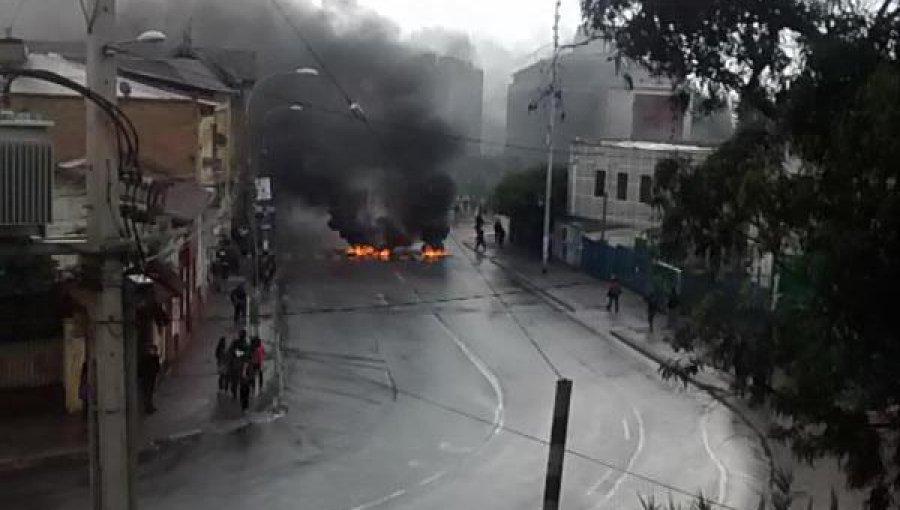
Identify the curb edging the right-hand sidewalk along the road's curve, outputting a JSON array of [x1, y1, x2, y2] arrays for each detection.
[[460, 242, 777, 488]]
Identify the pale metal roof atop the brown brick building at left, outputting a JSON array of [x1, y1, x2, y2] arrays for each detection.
[[11, 53, 191, 101]]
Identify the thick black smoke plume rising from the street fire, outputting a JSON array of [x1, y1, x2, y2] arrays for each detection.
[[175, 0, 461, 246]]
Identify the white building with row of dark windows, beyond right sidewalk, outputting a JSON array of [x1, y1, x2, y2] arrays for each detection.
[[567, 140, 715, 231]]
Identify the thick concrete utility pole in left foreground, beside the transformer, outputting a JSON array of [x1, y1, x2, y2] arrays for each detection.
[[85, 0, 135, 510]]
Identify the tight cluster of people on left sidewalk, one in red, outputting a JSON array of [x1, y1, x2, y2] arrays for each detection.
[[216, 329, 266, 412]]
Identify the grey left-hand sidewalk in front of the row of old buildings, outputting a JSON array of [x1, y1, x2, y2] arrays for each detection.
[[0, 291, 277, 473]]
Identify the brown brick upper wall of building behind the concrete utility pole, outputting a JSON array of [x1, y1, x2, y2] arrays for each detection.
[[11, 94, 200, 177]]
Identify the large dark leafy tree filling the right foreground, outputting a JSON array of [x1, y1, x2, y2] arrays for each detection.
[[583, 0, 900, 509]]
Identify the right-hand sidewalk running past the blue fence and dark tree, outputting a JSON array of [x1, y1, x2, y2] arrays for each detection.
[[458, 233, 866, 508]]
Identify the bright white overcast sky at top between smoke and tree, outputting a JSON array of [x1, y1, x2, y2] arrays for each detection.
[[326, 0, 580, 51]]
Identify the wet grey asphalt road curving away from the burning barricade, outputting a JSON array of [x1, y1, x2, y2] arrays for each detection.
[[0, 208, 764, 510]]
